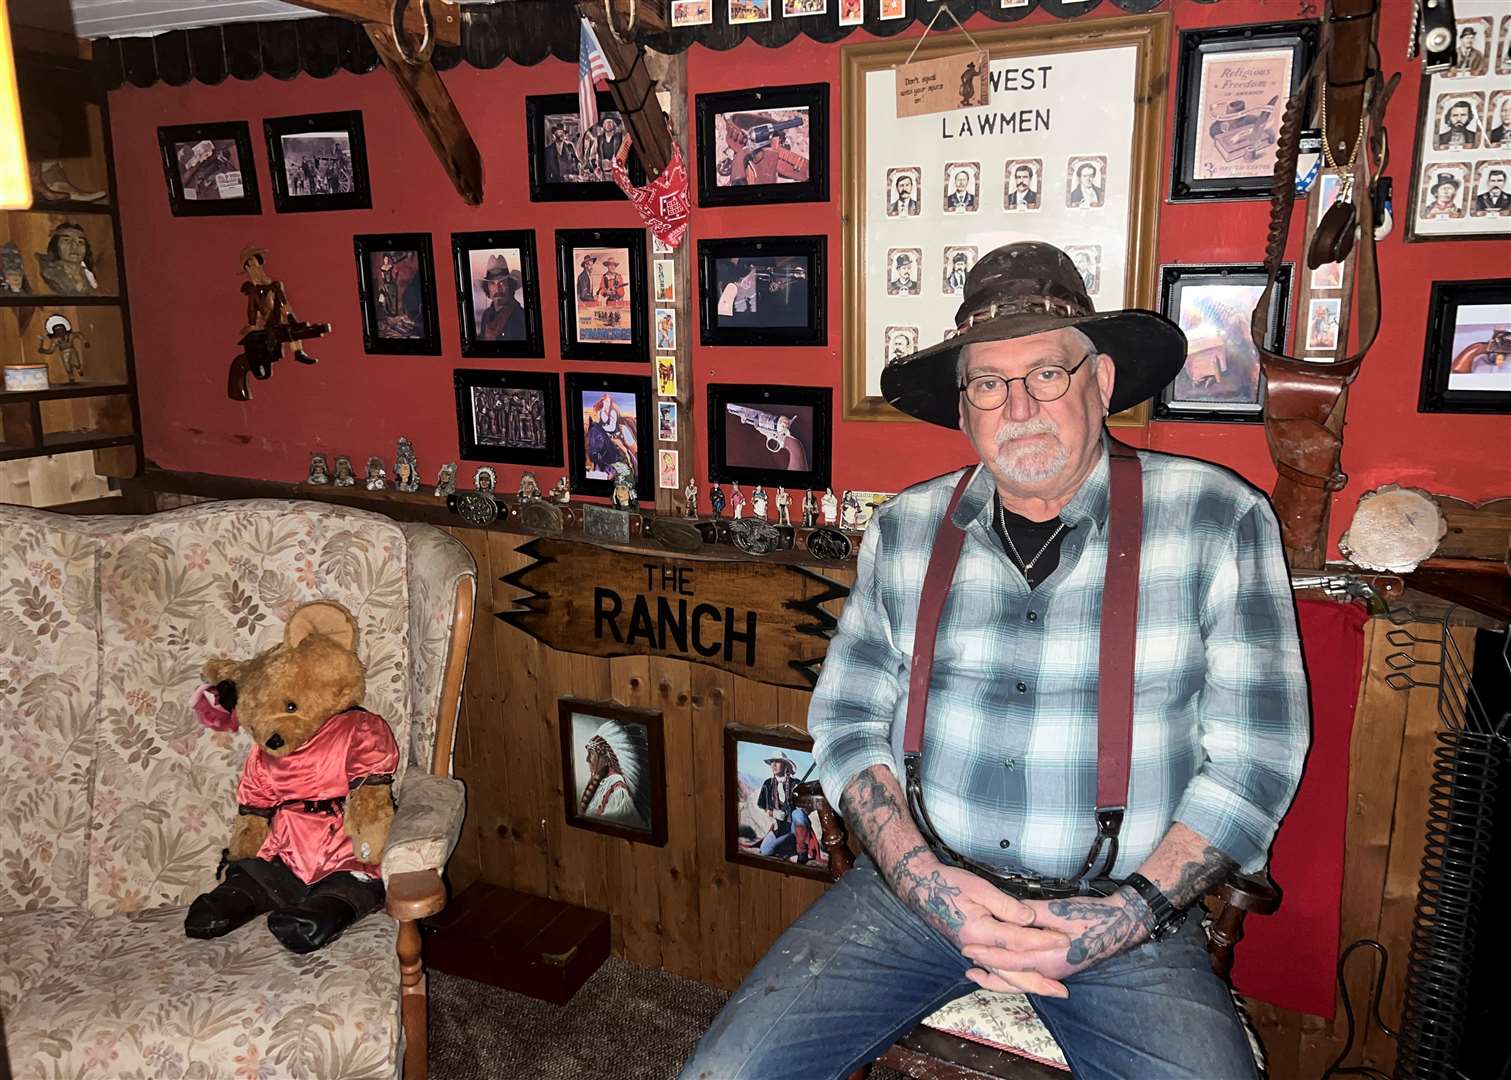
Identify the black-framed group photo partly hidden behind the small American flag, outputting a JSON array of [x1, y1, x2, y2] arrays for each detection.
[[524, 91, 645, 202]]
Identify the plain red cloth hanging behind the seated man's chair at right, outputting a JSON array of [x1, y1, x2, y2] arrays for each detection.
[[1233, 600, 1367, 1017]]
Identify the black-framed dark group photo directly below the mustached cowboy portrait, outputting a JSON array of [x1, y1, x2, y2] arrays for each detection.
[[452, 367, 562, 465]]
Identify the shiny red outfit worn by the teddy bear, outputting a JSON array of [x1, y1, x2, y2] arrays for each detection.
[[236, 708, 399, 885]]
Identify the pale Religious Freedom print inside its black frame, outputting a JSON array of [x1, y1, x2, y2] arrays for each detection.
[[1192, 48, 1295, 180]]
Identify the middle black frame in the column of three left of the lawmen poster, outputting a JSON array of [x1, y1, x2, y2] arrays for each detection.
[[698, 236, 828, 346]]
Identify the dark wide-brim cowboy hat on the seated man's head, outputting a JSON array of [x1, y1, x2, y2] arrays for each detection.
[[881, 242, 1186, 427]]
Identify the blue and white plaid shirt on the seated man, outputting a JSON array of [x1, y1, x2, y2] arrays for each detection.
[[808, 449, 1310, 878]]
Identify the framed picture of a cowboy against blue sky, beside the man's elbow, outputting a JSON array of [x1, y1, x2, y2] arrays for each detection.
[[724, 725, 830, 881]]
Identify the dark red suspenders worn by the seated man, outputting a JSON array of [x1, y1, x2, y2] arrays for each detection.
[[902, 440, 1144, 888]]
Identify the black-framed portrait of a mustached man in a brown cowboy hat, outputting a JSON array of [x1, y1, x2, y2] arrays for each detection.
[[452, 228, 545, 356]]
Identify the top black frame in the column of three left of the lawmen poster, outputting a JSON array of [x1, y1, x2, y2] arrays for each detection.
[[695, 83, 830, 207]]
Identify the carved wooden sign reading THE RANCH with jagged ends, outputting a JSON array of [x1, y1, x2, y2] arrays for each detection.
[[499, 539, 849, 690]]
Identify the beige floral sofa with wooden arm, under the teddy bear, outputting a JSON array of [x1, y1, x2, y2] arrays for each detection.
[[0, 500, 476, 1080]]
